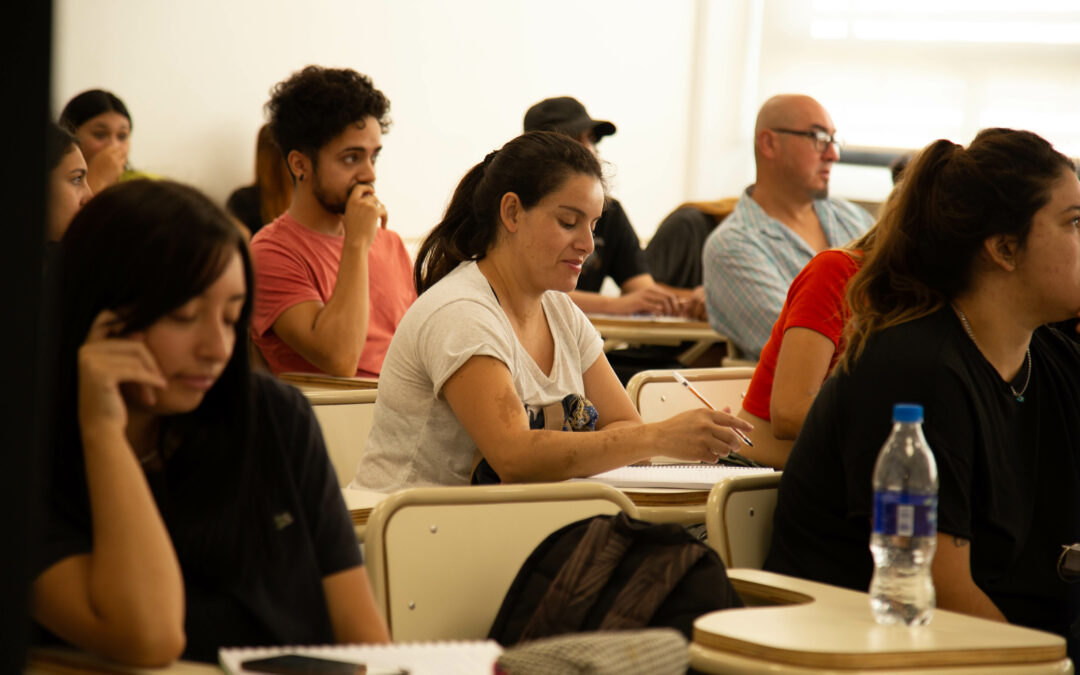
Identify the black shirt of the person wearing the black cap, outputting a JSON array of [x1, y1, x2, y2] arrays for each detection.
[[578, 199, 649, 293]]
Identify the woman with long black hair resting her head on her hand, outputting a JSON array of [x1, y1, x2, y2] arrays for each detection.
[[32, 180, 388, 665]]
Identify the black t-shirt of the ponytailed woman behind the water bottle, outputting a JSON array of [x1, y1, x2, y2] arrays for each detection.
[[765, 307, 1080, 650]]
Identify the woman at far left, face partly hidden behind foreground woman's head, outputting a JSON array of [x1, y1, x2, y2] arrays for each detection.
[[45, 121, 93, 244]]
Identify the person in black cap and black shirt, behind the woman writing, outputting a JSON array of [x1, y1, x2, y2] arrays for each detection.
[[524, 96, 704, 319]]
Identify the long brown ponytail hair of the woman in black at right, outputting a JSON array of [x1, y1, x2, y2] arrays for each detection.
[[840, 129, 1076, 368]]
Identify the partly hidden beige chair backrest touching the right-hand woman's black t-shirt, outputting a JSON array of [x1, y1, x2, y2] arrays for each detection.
[[705, 471, 781, 569]]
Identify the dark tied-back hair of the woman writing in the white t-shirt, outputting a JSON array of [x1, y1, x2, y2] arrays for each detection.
[[413, 132, 604, 293]]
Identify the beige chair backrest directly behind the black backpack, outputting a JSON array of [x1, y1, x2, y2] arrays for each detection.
[[365, 482, 637, 642]]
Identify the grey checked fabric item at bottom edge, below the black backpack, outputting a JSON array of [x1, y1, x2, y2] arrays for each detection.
[[499, 629, 690, 675]]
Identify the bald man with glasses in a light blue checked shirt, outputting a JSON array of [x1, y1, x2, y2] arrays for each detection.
[[702, 94, 873, 360]]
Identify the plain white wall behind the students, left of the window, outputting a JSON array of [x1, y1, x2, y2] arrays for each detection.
[[53, 0, 708, 246]]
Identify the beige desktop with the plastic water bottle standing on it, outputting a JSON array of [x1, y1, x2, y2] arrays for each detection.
[[690, 568, 1074, 675]]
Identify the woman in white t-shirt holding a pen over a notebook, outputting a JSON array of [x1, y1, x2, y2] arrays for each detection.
[[354, 132, 751, 491]]
